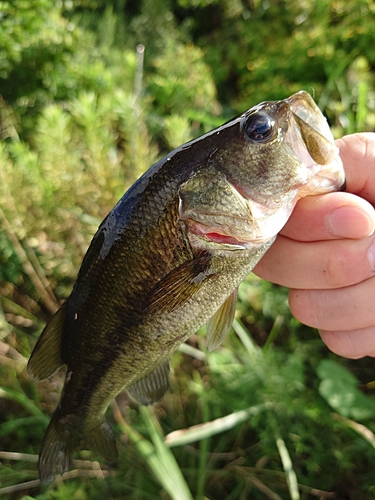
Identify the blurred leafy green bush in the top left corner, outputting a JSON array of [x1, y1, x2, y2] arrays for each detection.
[[0, 0, 79, 132]]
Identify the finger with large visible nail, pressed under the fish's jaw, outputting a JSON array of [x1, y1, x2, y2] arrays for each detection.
[[281, 193, 375, 241]]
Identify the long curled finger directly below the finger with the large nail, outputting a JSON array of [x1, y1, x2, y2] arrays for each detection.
[[253, 235, 375, 290]]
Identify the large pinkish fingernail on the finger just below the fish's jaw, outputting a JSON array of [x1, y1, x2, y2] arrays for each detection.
[[327, 205, 375, 238]]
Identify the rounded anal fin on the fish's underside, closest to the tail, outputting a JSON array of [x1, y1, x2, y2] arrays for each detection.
[[127, 359, 169, 405]]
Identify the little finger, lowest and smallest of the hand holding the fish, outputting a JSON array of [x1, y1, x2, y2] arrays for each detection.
[[319, 325, 375, 359]]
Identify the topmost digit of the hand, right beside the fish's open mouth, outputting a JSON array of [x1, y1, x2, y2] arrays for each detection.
[[336, 132, 375, 204]]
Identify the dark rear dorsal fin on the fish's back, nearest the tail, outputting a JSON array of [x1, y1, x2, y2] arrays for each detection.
[[27, 304, 65, 380]]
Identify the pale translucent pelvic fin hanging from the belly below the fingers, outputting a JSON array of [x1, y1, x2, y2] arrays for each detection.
[[207, 288, 238, 351]]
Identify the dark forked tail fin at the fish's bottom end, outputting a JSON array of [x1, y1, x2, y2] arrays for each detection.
[[38, 411, 118, 484]]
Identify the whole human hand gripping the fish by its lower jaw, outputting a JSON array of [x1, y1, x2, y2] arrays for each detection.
[[254, 133, 375, 359]]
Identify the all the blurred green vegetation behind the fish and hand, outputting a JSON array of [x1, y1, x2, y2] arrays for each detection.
[[0, 0, 375, 500]]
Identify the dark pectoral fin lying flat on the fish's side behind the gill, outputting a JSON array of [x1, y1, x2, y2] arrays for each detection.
[[145, 252, 214, 313]]
